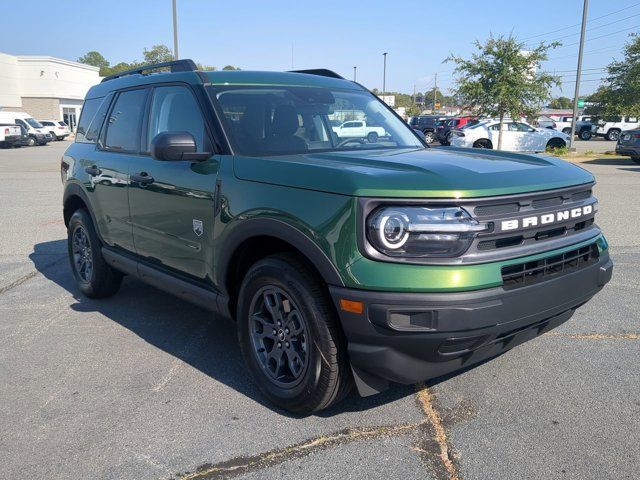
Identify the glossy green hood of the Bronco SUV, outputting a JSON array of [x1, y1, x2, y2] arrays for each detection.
[[234, 147, 594, 198]]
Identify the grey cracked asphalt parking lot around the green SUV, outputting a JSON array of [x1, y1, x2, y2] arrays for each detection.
[[0, 142, 640, 479]]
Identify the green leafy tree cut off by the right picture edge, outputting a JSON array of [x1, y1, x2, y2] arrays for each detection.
[[594, 33, 640, 117]]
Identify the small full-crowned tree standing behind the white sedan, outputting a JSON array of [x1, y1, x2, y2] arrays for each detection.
[[445, 35, 560, 150]]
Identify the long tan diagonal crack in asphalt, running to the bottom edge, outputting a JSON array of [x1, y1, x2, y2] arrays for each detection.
[[178, 422, 424, 480]]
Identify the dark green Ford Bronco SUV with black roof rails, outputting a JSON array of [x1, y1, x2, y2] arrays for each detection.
[[61, 60, 612, 414]]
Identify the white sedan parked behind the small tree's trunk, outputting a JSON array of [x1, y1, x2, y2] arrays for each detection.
[[451, 119, 569, 152]]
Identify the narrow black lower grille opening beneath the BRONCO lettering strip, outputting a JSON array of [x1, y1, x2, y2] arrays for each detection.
[[502, 243, 600, 290]]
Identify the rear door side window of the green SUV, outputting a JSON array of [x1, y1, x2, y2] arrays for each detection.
[[104, 89, 148, 153]]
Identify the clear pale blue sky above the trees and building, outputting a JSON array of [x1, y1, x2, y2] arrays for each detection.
[[0, 0, 640, 97]]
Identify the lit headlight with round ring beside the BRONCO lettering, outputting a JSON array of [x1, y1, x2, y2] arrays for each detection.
[[367, 207, 489, 258]]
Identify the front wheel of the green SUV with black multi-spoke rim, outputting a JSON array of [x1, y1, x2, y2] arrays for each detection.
[[237, 254, 352, 415]]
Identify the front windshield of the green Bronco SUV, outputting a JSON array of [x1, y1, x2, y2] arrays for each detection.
[[209, 86, 424, 156]]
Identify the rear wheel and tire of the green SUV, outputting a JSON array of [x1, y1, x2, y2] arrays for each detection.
[[67, 208, 123, 298]]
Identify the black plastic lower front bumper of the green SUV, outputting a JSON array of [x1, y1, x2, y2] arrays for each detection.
[[330, 250, 613, 396]]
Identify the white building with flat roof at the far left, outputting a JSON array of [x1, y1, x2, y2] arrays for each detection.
[[0, 53, 100, 130]]
